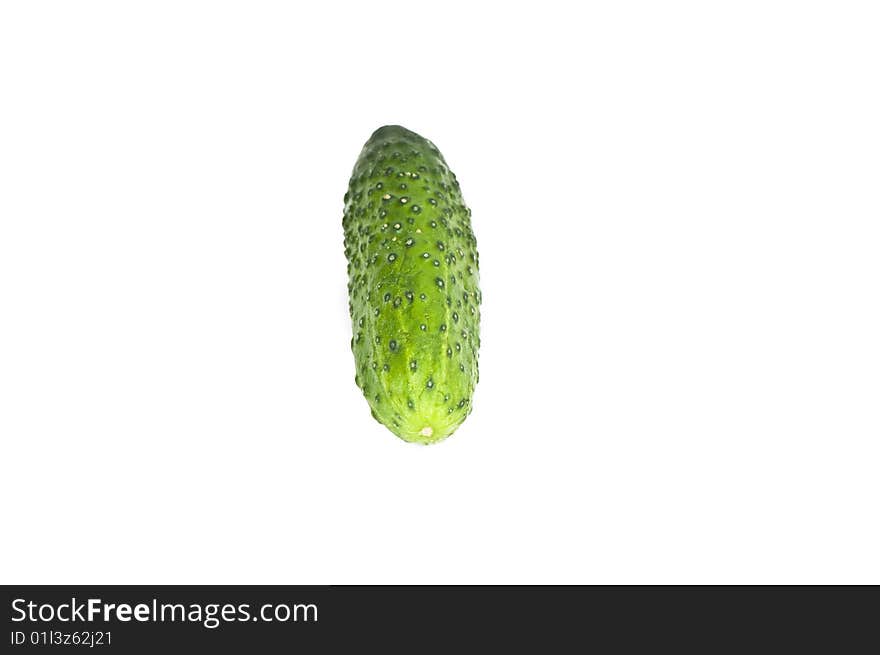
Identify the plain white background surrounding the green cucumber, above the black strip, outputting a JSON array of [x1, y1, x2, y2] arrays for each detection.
[[0, 1, 880, 583]]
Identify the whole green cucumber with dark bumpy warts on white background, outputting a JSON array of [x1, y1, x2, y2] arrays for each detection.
[[342, 125, 482, 444]]
